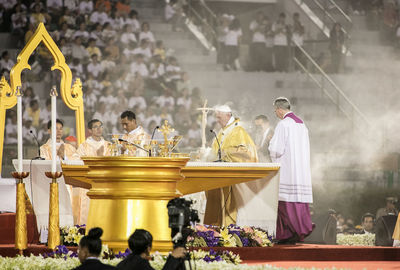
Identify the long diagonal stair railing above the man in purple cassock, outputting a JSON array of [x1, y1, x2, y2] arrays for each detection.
[[292, 40, 371, 130]]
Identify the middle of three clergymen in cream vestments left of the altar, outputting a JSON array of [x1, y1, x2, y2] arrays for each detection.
[[72, 119, 111, 224]]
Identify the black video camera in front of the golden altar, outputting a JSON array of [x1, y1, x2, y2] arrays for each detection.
[[167, 198, 200, 248]]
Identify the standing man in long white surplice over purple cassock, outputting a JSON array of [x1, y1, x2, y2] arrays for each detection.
[[269, 97, 313, 243]]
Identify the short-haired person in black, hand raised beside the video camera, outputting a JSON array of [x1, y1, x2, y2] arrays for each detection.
[[117, 229, 185, 270]]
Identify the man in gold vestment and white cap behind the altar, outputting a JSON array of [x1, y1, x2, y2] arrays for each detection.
[[204, 105, 258, 226]]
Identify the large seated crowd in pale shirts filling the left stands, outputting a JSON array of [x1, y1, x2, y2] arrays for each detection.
[[0, 0, 212, 150]]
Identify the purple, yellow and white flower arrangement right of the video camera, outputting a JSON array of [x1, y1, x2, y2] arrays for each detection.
[[187, 224, 273, 247]]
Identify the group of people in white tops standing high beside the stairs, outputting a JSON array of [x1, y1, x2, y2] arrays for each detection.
[[217, 11, 305, 72]]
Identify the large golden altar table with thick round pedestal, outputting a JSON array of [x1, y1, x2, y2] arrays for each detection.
[[62, 156, 279, 252]]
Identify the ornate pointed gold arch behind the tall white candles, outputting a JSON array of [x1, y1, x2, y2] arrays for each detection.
[[0, 23, 85, 173]]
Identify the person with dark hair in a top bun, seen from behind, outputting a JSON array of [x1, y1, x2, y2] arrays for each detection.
[[74, 227, 115, 270]]
